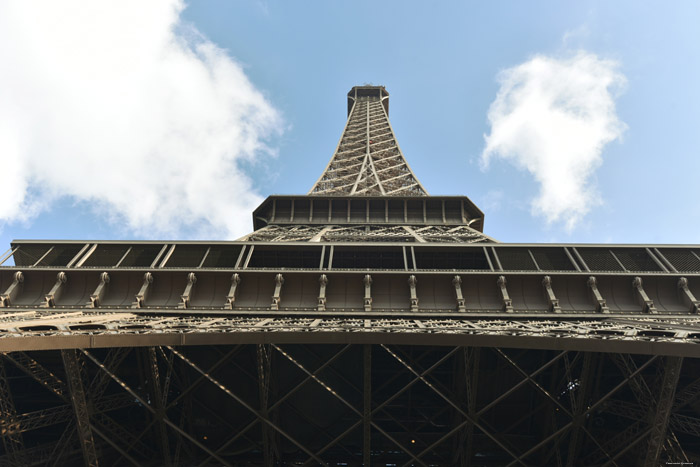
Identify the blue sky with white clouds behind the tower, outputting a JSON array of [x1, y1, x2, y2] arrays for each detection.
[[0, 0, 700, 252]]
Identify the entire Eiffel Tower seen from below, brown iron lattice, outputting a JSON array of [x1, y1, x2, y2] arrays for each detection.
[[0, 86, 700, 466]]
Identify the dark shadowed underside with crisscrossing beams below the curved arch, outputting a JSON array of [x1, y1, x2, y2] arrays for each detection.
[[0, 339, 700, 466]]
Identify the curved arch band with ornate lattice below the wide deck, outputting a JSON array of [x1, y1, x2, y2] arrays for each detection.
[[0, 308, 700, 357]]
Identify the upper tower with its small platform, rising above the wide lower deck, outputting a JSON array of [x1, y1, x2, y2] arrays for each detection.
[[249, 86, 493, 243]]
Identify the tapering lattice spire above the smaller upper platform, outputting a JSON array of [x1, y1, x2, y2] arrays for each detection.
[[309, 86, 428, 196]]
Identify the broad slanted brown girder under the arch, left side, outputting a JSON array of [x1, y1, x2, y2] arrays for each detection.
[[61, 349, 98, 467]]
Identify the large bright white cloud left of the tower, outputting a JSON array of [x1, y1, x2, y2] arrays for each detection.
[[0, 0, 282, 238]]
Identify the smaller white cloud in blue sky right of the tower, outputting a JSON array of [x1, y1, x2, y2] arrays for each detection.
[[481, 52, 626, 230]]
